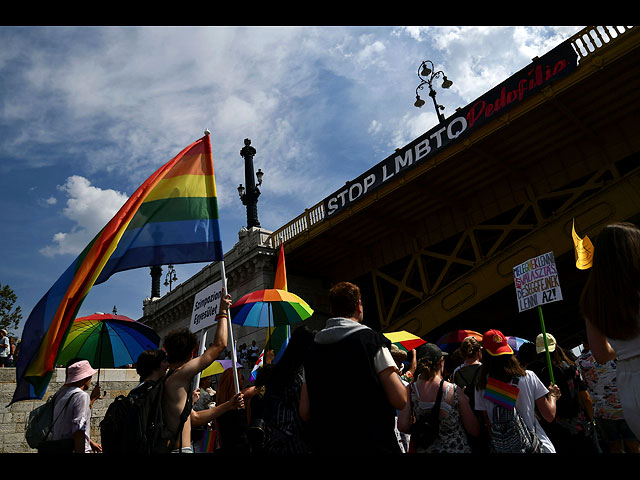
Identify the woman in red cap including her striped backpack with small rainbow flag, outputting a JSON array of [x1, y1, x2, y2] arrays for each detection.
[[475, 330, 560, 453]]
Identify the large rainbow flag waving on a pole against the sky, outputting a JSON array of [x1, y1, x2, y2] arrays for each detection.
[[11, 133, 224, 403]]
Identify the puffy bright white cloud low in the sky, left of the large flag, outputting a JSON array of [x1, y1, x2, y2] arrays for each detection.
[[40, 175, 128, 257]]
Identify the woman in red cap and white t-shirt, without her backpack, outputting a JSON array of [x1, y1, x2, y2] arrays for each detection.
[[475, 330, 560, 453]]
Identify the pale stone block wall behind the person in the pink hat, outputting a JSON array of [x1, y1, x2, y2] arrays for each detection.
[[0, 368, 139, 453]]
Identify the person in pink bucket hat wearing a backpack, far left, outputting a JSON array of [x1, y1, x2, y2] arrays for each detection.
[[51, 360, 102, 453]]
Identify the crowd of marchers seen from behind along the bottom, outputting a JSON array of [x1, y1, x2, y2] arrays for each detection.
[[40, 224, 640, 454]]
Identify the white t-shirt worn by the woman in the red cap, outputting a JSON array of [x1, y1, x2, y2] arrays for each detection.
[[475, 370, 556, 453]]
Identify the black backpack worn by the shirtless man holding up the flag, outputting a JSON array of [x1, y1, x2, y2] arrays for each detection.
[[100, 375, 182, 454]]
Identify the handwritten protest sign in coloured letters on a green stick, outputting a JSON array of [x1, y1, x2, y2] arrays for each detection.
[[513, 252, 562, 312]]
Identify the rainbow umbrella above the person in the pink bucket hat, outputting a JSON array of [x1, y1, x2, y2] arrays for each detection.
[[56, 313, 160, 378]]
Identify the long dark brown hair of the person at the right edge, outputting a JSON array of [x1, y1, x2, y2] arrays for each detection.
[[580, 222, 640, 340]]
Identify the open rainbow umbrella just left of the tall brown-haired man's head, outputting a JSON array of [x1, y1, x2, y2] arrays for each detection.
[[231, 288, 313, 328]]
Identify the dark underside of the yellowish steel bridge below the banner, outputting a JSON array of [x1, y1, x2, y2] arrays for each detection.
[[285, 30, 640, 346]]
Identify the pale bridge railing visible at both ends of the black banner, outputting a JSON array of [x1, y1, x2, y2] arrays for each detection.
[[269, 26, 637, 248]]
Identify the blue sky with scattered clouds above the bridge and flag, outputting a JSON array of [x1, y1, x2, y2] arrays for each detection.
[[0, 26, 581, 334]]
